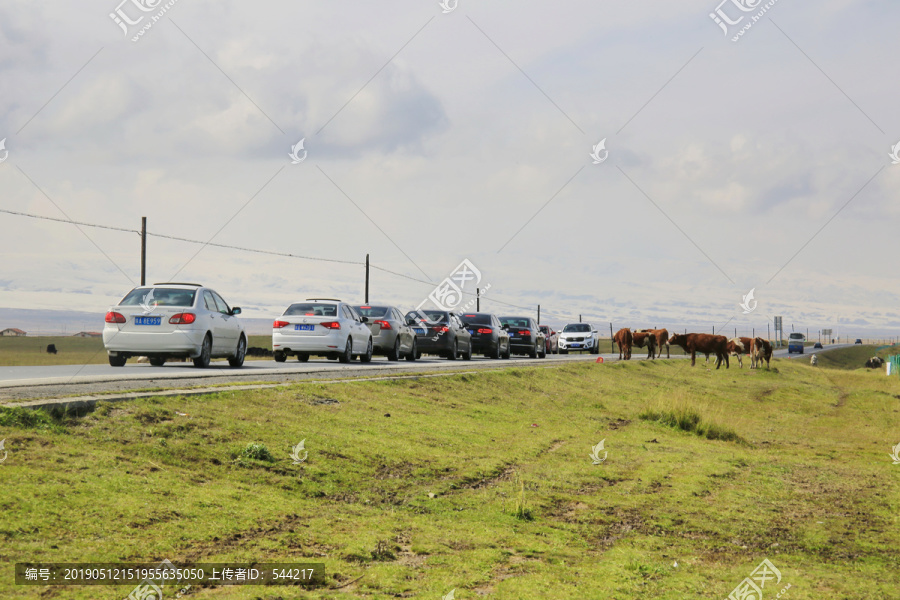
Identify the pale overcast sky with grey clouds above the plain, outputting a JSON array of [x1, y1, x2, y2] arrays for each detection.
[[0, 0, 900, 335]]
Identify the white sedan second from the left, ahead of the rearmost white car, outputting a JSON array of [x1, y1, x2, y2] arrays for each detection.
[[272, 298, 374, 363]]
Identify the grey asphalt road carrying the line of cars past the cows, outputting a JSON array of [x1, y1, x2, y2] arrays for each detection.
[[0, 344, 850, 401]]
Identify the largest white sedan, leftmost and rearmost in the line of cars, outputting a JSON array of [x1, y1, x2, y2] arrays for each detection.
[[103, 283, 247, 369]]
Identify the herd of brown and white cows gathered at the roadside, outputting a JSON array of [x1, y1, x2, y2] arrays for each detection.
[[613, 327, 772, 369]]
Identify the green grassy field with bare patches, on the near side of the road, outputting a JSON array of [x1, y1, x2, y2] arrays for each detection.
[[0, 360, 900, 600]]
